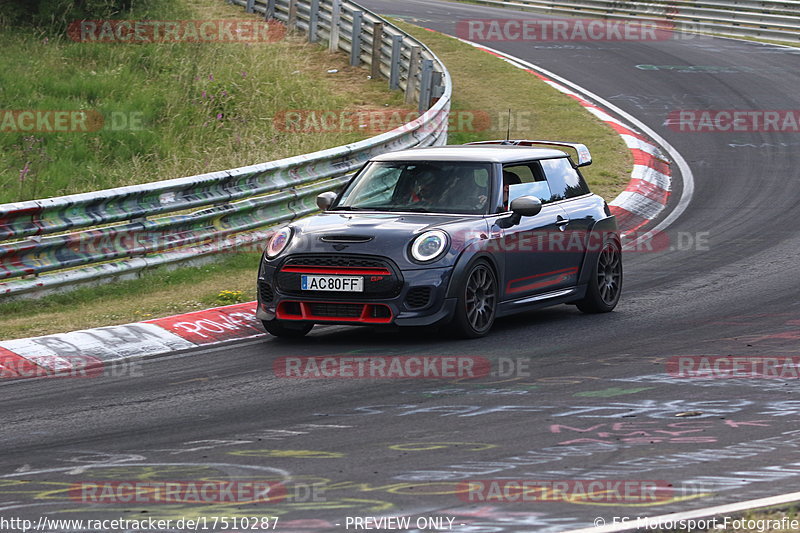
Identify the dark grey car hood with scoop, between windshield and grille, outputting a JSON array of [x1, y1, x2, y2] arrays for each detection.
[[281, 212, 488, 269]]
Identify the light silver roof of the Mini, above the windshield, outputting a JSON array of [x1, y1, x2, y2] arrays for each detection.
[[371, 144, 567, 163]]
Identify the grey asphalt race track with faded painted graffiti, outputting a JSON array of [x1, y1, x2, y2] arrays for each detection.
[[0, 0, 800, 533]]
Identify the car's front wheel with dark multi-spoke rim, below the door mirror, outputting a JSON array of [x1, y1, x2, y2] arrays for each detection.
[[454, 261, 498, 339]]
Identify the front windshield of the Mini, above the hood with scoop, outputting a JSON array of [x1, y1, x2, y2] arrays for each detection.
[[333, 161, 491, 215]]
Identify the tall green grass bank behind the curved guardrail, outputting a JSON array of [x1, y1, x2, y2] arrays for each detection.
[[0, 0, 401, 203]]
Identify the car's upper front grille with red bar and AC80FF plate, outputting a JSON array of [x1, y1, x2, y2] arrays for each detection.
[[275, 254, 403, 300]]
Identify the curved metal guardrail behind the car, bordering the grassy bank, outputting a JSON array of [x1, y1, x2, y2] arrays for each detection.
[[0, 0, 452, 297]]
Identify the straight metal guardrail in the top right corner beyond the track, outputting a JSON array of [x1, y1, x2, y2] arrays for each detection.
[[460, 0, 800, 43]]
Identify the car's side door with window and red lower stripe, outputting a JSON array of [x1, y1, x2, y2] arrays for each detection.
[[492, 161, 578, 300]]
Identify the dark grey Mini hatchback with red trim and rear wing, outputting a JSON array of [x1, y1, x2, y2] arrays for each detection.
[[257, 140, 622, 337]]
